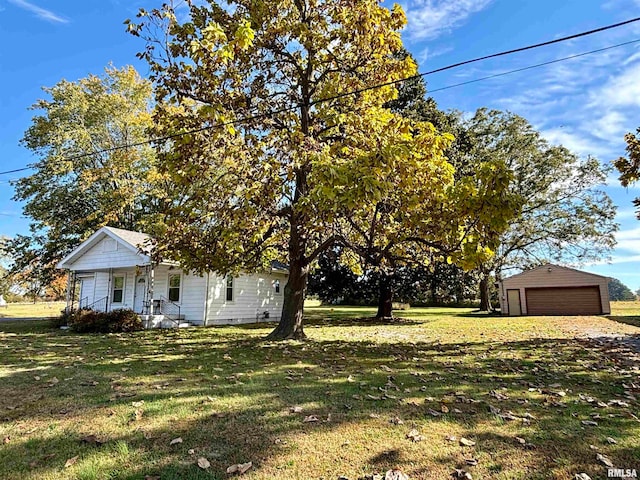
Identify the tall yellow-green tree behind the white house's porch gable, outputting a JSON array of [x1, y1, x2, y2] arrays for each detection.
[[7, 63, 158, 289]]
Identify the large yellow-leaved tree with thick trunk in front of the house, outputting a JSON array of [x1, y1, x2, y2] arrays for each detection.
[[128, 0, 468, 339]]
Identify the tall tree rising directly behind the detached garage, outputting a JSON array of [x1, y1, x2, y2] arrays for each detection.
[[465, 109, 618, 310]]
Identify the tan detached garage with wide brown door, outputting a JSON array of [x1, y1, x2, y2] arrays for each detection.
[[499, 264, 611, 316]]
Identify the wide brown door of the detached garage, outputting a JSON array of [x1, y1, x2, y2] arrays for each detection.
[[525, 285, 602, 315]]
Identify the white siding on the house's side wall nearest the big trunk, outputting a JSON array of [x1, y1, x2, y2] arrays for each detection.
[[206, 273, 287, 325]]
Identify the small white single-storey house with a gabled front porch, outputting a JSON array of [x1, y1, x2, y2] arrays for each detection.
[[58, 227, 288, 328]]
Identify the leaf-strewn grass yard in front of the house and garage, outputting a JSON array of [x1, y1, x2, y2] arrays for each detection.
[[0, 304, 640, 480]]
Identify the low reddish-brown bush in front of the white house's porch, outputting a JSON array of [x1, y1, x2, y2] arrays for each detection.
[[65, 309, 144, 333]]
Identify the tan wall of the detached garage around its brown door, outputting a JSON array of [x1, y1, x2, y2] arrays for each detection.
[[500, 265, 611, 315]]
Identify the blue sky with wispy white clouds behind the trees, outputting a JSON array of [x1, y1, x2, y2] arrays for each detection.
[[0, 0, 640, 290]]
